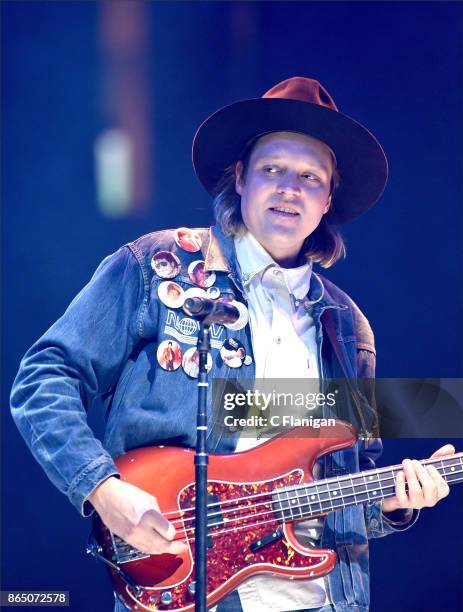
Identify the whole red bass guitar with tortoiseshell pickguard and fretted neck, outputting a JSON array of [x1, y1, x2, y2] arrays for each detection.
[[88, 421, 463, 612]]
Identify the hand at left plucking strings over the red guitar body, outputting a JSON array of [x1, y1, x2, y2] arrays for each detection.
[[87, 476, 187, 555]]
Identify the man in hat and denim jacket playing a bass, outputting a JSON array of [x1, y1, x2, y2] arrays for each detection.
[[12, 77, 454, 612]]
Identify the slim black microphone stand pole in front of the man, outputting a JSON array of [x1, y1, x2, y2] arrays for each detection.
[[194, 321, 211, 612]]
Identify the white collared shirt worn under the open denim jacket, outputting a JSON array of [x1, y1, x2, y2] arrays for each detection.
[[235, 233, 329, 612]]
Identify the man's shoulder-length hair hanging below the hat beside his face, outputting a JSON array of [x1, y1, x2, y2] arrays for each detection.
[[212, 145, 346, 268]]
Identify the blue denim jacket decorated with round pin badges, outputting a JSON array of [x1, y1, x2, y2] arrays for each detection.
[[11, 227, 417, 611]]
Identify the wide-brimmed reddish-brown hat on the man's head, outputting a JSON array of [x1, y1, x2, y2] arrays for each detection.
[[193, 77, 387, 223]]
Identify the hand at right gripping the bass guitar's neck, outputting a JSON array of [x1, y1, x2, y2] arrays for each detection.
[[382, 444, 455, 513]]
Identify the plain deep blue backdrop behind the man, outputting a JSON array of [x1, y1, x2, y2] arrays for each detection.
[[1, 1, 463, 612]]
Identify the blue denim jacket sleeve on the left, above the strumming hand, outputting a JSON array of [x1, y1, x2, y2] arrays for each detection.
[[11, 247, 147, 516]]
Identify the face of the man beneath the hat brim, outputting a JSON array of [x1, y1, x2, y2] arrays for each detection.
[[236, 132, 333, 266]]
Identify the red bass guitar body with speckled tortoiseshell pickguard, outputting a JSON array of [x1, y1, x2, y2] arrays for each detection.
[[96, 421, 356, 611]]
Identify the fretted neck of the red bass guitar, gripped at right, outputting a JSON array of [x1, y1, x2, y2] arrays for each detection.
[[275, 453, 463, 521]]
